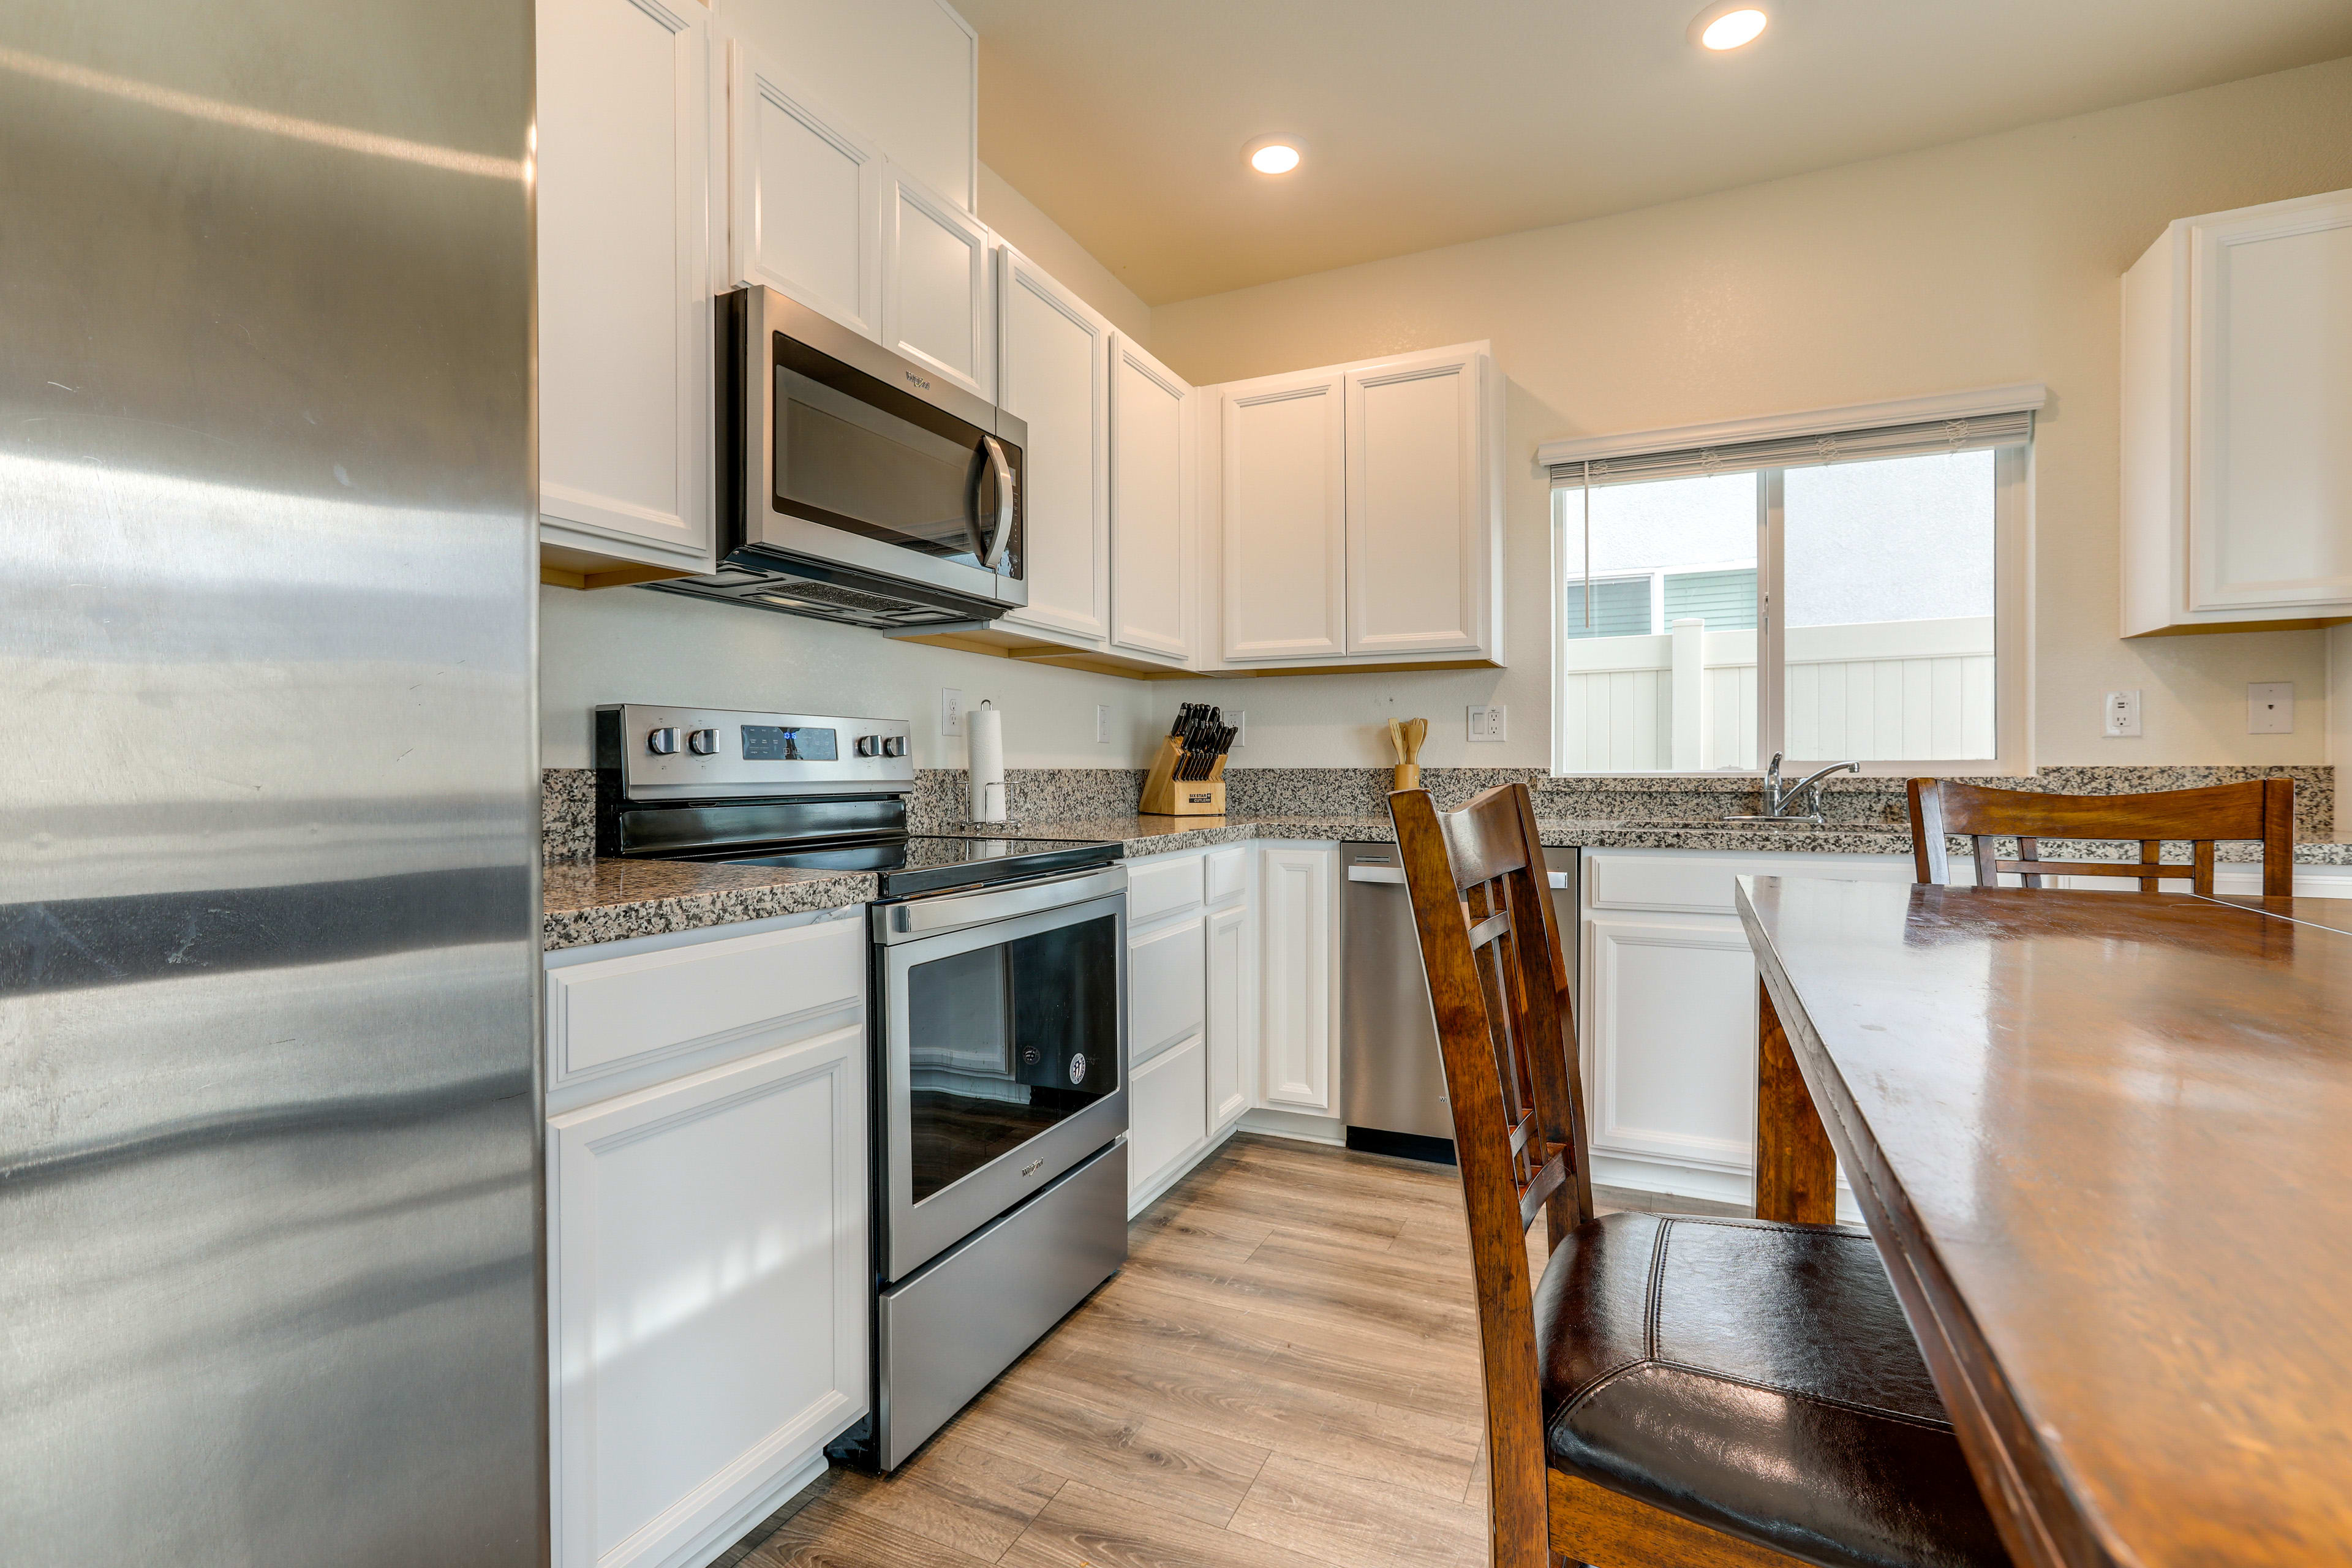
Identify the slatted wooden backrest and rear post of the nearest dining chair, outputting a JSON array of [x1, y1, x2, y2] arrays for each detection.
[[1388, 783, 1593, 1568]]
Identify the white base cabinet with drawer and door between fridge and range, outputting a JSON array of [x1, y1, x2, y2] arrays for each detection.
[[546, 912, 870, 1568]]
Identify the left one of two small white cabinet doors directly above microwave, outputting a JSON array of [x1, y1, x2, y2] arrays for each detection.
[[727, 40, 884, 341]]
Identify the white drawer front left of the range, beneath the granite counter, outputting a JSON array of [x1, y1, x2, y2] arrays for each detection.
[[548, 919, 865, 1084]]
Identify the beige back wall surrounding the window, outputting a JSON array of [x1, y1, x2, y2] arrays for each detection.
[[1152, 59, 2352, 766]]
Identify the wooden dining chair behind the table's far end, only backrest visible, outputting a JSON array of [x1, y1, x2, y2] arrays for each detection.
[[1910, 778, 2296, 898]]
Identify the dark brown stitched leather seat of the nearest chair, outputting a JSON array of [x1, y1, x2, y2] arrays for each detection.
[[1534, 1213, 2008, 1568]]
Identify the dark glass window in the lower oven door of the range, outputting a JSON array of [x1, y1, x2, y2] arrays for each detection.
[[905, 914, 1120, 1204]]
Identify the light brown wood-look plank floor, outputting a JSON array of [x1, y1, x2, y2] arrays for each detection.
[[720, 1133, 1740, 1568]]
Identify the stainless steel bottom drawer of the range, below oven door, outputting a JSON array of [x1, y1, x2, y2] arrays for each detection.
[[875, 1133, 1126, 1469]]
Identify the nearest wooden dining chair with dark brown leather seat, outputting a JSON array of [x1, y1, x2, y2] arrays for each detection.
[[1388, 783, 2008, 1568]]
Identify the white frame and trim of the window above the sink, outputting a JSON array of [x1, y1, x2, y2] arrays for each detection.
[[1536, 399, 2046, 778]]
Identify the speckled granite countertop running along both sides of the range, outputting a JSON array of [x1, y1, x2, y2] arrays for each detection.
[[541, 813, 2352, 952]]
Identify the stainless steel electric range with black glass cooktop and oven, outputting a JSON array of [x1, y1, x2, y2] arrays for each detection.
[[595, 703, 1126, 1469]]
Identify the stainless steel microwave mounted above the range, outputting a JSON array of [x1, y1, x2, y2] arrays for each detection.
[[647, 289, 1028, 630]]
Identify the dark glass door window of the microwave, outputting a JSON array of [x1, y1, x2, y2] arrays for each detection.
[[774, 334, 1021, 576]]
